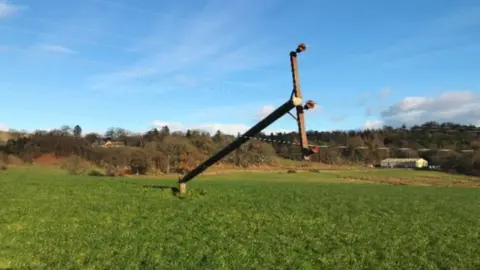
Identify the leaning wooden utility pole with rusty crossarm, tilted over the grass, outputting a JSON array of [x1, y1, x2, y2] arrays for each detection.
[[178, 43, 318, 194]]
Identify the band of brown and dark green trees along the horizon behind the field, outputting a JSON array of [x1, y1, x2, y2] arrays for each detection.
[[0, 122, 480, 175]]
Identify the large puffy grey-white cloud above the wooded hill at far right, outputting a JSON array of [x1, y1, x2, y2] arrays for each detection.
[[381, 91, 480, 126]]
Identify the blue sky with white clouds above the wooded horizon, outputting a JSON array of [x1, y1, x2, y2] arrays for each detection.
[[0, 0, 480, 133]]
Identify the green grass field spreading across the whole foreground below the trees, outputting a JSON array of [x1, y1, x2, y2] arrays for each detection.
[[0, 169, 480, 269]]
